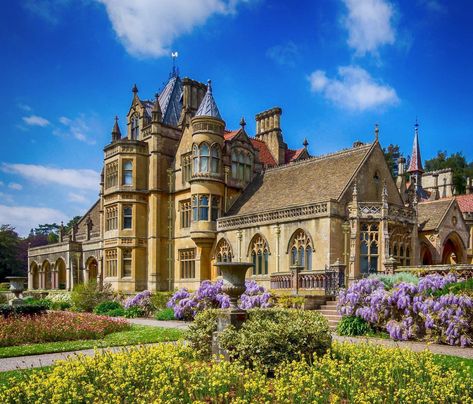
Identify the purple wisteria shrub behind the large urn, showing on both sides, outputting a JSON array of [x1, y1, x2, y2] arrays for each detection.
[[167, 280, 271, 320]]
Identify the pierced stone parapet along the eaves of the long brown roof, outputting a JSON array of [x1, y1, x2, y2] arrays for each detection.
[[217, 202, 328, 230]]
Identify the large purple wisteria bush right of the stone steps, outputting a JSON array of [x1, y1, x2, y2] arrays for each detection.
[[338, 274, 473, 346]]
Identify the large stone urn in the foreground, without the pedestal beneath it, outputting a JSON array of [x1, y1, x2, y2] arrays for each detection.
[[215, 262, 253, 311]]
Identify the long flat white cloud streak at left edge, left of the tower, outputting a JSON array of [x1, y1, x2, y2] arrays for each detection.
[[1, 163, 100, 191]]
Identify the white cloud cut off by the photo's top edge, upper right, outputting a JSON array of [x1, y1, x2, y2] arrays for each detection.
[[343, 0, 396, 56]]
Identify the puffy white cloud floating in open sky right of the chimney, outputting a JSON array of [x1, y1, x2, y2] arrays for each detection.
[[309, 66, 399, 111]]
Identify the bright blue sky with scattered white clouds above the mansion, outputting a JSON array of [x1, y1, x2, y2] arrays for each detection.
[[0, 0, 473, 235]]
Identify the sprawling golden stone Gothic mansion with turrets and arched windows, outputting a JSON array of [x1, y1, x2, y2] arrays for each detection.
[[28, 72, 473, 294]]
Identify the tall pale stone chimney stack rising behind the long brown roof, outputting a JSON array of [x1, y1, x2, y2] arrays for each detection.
[[256, 107, 287, 164]]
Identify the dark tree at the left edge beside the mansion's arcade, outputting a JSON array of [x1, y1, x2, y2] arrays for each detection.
[[0, 224, 24, 282]]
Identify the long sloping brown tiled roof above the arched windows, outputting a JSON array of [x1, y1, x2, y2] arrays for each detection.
[[228, 144, 372, 215]]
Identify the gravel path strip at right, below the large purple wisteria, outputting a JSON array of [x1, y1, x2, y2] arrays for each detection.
[[333, 334, 473, 359]]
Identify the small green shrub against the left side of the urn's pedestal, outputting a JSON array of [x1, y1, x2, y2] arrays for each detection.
[[185, 309, 220, 359]]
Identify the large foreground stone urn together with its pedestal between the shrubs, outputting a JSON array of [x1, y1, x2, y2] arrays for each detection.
[[212, 262, 253, 358]]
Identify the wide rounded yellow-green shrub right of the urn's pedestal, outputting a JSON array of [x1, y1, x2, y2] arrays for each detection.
[[219, 309, 332, 371]]
